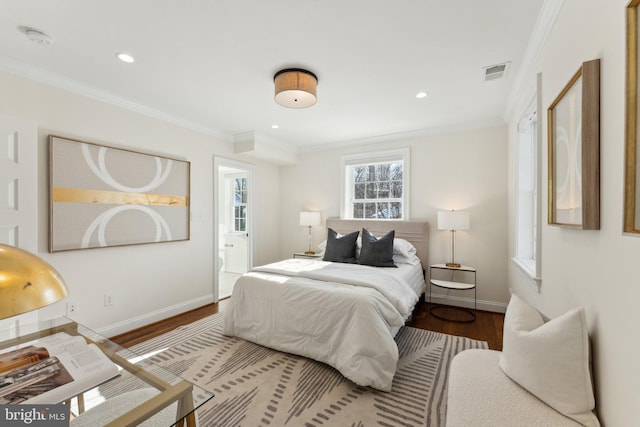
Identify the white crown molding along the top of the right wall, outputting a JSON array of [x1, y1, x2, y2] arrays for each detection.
[[503, 0, 564, 121]]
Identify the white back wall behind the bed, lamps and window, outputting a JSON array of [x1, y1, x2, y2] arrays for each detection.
[[280, 127, 508, 311]]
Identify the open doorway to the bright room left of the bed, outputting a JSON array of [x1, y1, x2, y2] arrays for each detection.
[[213, 157, 254, 301]]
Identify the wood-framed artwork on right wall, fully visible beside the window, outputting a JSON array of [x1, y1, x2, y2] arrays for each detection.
[[547, 59, 600, 230]]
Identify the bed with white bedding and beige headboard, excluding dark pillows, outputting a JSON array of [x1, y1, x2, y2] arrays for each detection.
[[224, 218, 428, 391]]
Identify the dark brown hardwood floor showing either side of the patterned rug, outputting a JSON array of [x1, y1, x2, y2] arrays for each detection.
[[111, 300, 504, 350]]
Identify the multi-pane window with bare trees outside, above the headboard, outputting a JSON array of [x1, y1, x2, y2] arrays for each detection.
[[342, 149, 409, 219]]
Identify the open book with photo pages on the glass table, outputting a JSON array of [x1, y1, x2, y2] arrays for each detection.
[[0, 332, 119, 404]]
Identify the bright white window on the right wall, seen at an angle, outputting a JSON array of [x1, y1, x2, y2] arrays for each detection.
[[512, 89, 542, 289]]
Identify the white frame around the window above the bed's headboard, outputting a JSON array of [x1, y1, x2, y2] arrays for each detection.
[[340, 148, 411, 221]]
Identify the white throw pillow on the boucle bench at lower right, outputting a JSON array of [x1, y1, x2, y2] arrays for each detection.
[[499, 294, 600, 426]]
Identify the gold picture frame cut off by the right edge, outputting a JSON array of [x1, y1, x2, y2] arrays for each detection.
[[623, 0, 640, 233]]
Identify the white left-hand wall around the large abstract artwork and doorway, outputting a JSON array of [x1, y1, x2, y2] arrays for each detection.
[[0, 73, 279, 334]]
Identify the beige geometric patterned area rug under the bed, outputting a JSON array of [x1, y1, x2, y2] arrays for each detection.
[[131, 312, 487, 427]]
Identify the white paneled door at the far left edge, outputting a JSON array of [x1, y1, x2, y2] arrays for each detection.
[[0, 115, 38, 337]]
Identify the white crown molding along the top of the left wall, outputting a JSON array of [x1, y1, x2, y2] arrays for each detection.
[[0, 56, 233, 142]]
